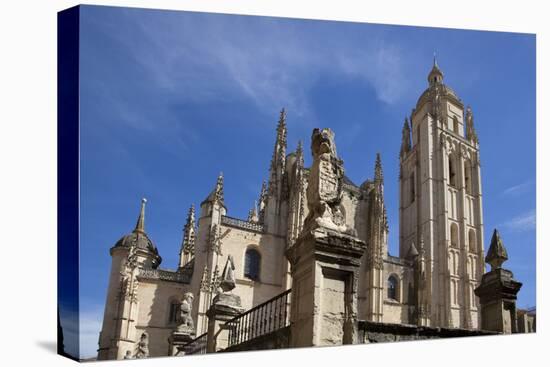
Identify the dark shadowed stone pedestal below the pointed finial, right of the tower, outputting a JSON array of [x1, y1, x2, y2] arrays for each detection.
[[475, 268, 522, 334]]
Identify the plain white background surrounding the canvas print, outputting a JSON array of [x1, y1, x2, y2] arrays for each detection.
[[0, 0, 550, 366]]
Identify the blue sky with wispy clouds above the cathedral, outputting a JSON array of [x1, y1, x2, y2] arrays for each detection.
[[71, 6, 536, 356]]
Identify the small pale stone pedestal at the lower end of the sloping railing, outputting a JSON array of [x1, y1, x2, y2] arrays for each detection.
[[206, 293, 244, 353]]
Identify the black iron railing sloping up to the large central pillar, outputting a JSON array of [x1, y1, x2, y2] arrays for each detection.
[[224, 289, 290, 347]]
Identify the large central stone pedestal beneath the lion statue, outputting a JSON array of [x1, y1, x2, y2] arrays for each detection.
[[286, 227, 366, 347]]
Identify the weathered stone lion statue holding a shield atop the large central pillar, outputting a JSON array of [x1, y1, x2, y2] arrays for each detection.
[[304, 129, 350, 232]]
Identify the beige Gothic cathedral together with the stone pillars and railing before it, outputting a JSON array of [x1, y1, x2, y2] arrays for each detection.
[[98, 60, 533, 360]]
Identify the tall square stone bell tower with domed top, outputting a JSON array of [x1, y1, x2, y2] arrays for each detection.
[[399, 58, 484, 328]]
